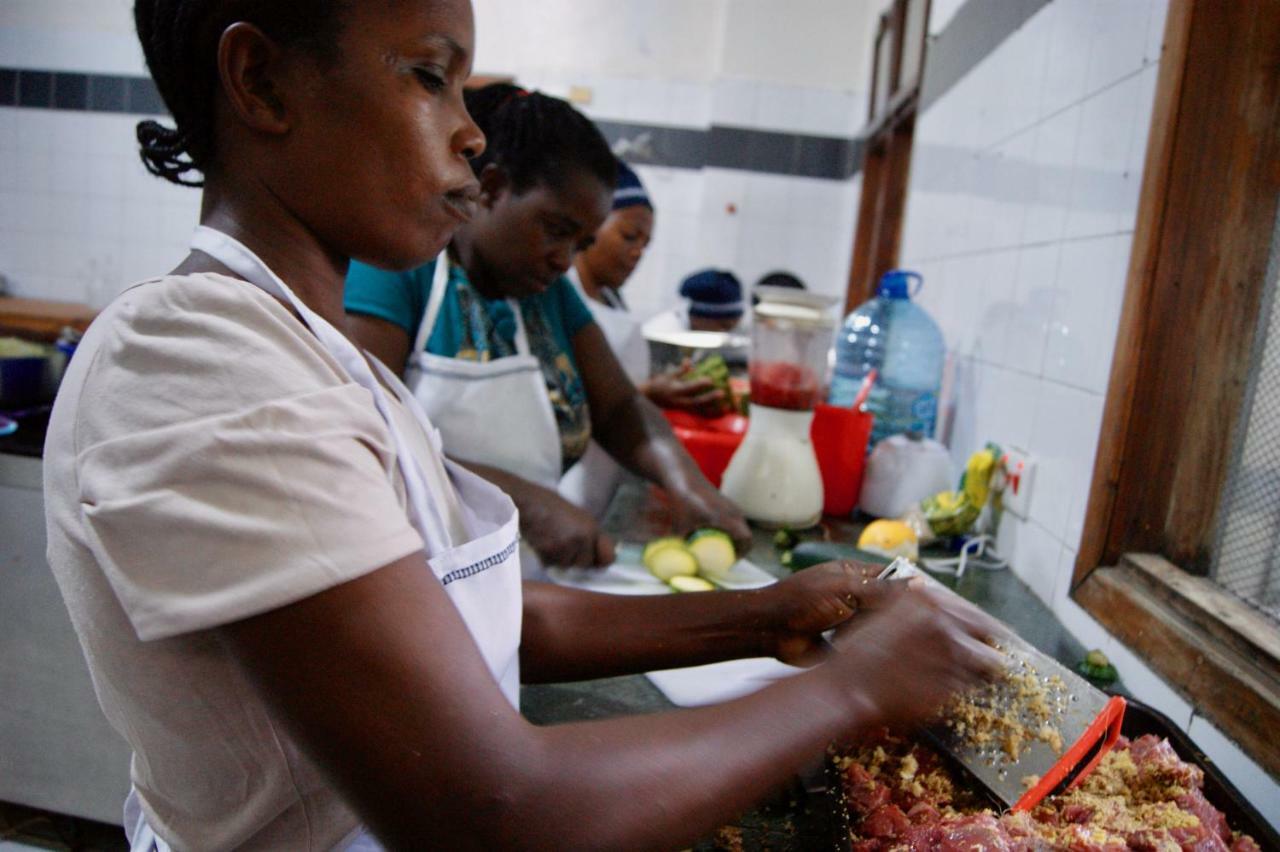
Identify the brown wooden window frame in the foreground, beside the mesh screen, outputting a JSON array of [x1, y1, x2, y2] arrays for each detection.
[[1071, 0, 1280, 777]]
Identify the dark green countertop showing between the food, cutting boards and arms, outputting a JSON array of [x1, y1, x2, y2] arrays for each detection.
[[521, 481, 1085, 852]]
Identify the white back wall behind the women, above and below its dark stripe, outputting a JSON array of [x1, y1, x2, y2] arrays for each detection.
[[0, 0, 877, 315]]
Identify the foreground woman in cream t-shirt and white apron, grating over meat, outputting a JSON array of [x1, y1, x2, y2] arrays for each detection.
[[45, 0, 1008, 852]]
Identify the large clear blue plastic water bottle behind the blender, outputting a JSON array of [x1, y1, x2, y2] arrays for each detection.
[[828, 270, 947, 445]]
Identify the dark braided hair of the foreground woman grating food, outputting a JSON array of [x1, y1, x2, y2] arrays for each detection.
[[133, 0, 349, 187]]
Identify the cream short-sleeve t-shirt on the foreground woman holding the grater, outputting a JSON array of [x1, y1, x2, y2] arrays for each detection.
[[45, 274, 476, 849]]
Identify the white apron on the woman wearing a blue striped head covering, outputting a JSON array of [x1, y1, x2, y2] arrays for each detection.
[[559, 269, 649, 518]]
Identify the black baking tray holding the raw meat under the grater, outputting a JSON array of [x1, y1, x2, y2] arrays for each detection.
[[827, 696, 1280, 852]]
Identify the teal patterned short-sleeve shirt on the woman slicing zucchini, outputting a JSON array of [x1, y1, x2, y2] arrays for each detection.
[[346, 261, 595, 469]]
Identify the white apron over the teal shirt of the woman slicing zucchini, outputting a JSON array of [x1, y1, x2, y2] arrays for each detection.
[[404, 251, 563, 580]]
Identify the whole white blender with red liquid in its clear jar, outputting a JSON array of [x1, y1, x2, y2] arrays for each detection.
[[721, 297, 835, 528]]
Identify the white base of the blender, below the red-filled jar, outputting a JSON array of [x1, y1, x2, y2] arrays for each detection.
[[721, 404, 823, 528]]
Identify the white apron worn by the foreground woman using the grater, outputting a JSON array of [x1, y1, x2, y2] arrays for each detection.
[[124, 226, 522, 852]]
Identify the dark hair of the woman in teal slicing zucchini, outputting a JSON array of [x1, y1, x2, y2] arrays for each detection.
[[465, 83, 618, 194]]
